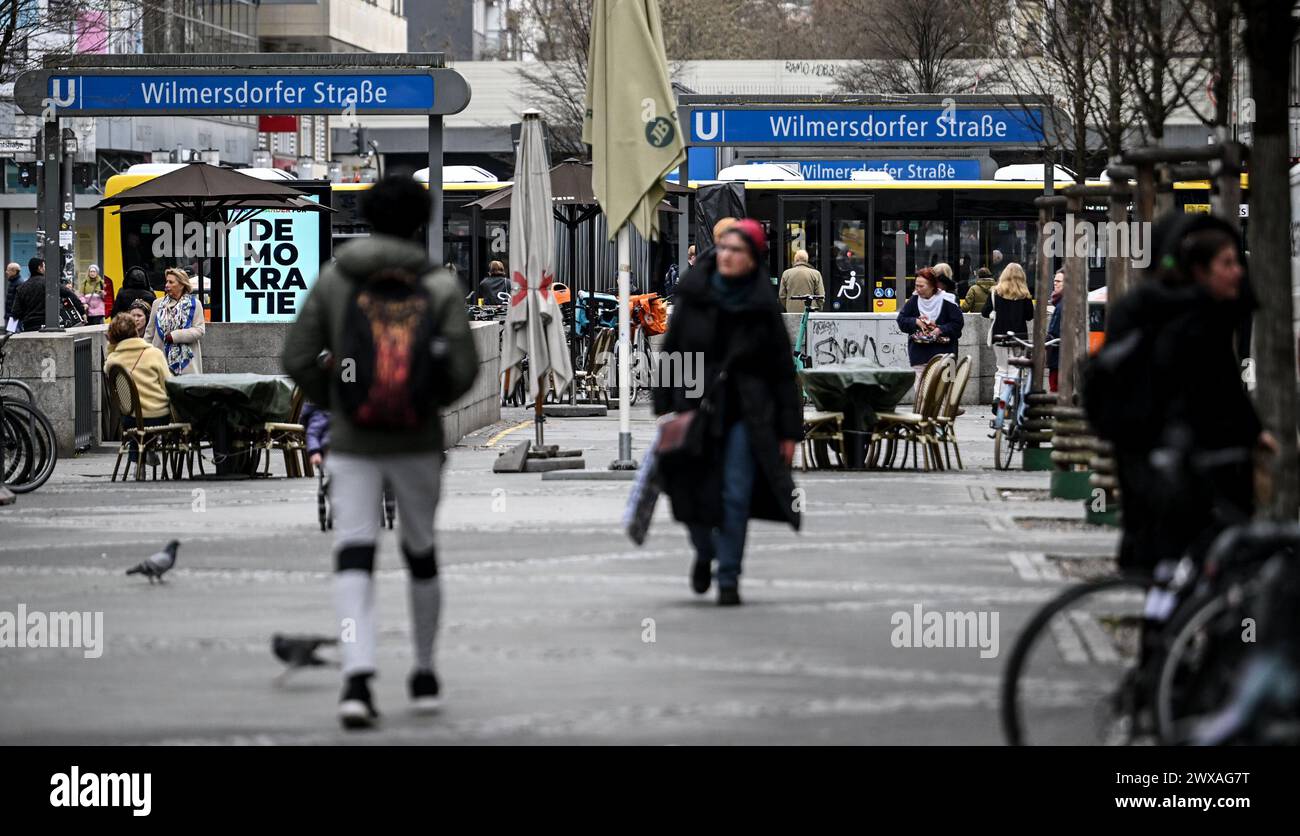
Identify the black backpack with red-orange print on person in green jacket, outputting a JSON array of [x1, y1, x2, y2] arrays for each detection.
[[334, 268, 443, 430]]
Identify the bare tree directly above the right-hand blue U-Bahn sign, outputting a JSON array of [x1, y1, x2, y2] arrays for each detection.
[[839, 0, 1000, 95]]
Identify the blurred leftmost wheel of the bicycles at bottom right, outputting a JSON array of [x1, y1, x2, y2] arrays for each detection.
[[1001, 577, 1148, 746]]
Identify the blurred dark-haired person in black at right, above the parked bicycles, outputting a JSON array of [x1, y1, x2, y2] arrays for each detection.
[[1084, 216, 1277, 573]]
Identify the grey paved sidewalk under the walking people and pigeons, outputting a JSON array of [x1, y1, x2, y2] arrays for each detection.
[[0, 408, 1115, 744]]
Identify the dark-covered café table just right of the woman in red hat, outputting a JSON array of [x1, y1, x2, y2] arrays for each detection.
[[800, 358, 917, 469]]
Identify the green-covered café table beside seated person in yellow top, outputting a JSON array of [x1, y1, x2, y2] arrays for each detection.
[[166, 373, 294, 478]]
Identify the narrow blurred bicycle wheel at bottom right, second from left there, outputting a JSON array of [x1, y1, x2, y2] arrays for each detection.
[[1156, 590, 1252, 745]]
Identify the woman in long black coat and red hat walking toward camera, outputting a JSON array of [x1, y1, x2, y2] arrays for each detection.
[[654, 218, 803, 606]]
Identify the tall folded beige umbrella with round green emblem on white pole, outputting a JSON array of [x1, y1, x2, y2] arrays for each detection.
[[582, 0, 686, 469]]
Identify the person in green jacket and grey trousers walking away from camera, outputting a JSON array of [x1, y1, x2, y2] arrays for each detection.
[[281, 176, 478, 728]]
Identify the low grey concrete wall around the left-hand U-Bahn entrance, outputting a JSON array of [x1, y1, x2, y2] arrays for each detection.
[[4, 322, 501, 455]]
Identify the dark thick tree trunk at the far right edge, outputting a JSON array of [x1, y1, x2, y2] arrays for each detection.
[[1242, 0, 1300, 520]]
